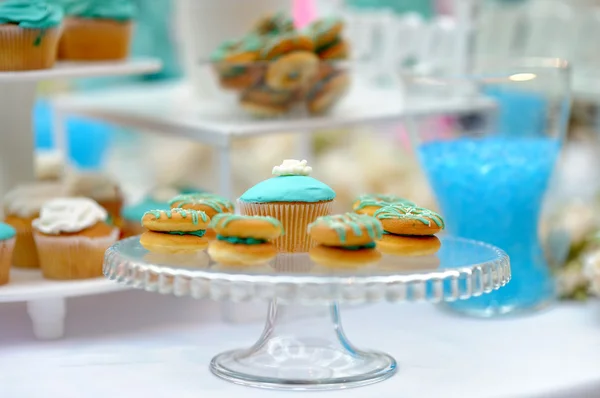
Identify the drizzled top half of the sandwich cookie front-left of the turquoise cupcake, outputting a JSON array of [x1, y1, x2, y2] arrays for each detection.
[[210, 214, 283, 240]]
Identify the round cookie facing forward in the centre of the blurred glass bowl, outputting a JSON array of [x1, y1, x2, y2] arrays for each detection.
[[265, 51, 319, 91]]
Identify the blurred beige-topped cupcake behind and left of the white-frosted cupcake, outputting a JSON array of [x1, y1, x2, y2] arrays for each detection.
[[4, 182, 66, 268]]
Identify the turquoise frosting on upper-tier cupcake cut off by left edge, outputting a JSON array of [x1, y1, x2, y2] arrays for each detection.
[[0, 0, 64, 29]]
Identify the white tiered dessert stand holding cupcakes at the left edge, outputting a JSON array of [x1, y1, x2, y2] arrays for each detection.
[[0, 58, 161, 339]]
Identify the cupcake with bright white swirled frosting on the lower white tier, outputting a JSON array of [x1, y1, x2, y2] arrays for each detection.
[[32, 197, 119, 280]]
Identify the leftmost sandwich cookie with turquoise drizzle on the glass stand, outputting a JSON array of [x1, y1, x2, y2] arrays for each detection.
[[140, 209, 210, 254]]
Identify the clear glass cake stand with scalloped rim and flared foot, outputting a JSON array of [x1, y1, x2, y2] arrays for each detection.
[[104, 237, 510, 390]]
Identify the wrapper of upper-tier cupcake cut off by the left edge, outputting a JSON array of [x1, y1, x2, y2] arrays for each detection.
[[0, 24, 61, 71]]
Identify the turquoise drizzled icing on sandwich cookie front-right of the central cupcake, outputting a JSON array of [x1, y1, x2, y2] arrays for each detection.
[[308, 213, 383, 243]]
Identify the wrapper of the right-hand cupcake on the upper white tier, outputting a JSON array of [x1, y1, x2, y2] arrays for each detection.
[[58, 18, 133, 61]]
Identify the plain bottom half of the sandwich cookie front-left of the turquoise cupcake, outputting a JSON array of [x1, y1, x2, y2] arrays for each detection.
[[208, 240, 277, 266]]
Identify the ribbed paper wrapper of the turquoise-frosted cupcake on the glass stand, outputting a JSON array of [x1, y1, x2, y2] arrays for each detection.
[[238, 200, 333, 253]]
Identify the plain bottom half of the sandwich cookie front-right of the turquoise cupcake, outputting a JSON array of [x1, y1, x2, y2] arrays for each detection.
[[308, 245, 381, 268]]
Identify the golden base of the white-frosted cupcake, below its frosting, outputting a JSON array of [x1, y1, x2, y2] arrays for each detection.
[[34, 228, 119, 280]]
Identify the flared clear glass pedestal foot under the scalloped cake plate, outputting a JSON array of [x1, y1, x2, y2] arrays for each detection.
[[210, 300, 396, 390]]
